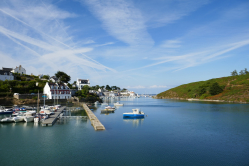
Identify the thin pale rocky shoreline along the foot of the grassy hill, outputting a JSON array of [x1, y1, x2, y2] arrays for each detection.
[[153, 96, 249, 104]]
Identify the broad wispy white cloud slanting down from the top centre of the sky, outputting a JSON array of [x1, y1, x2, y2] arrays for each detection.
[[82, 0, 154, 45]]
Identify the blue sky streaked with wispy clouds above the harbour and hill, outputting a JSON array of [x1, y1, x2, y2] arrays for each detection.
[[0, 0, 249, 94]]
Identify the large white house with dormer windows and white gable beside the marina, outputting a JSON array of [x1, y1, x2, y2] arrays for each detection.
[[43, 82, 71, 99]]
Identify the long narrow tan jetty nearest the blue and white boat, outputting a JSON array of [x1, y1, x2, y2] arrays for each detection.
[[83, 103, 105, 130]]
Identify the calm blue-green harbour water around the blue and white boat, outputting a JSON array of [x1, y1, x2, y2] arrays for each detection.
[[0, 98, 249, 166]]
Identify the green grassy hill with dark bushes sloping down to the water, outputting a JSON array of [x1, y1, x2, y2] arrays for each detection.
[[155, 74, 249, 102]]
